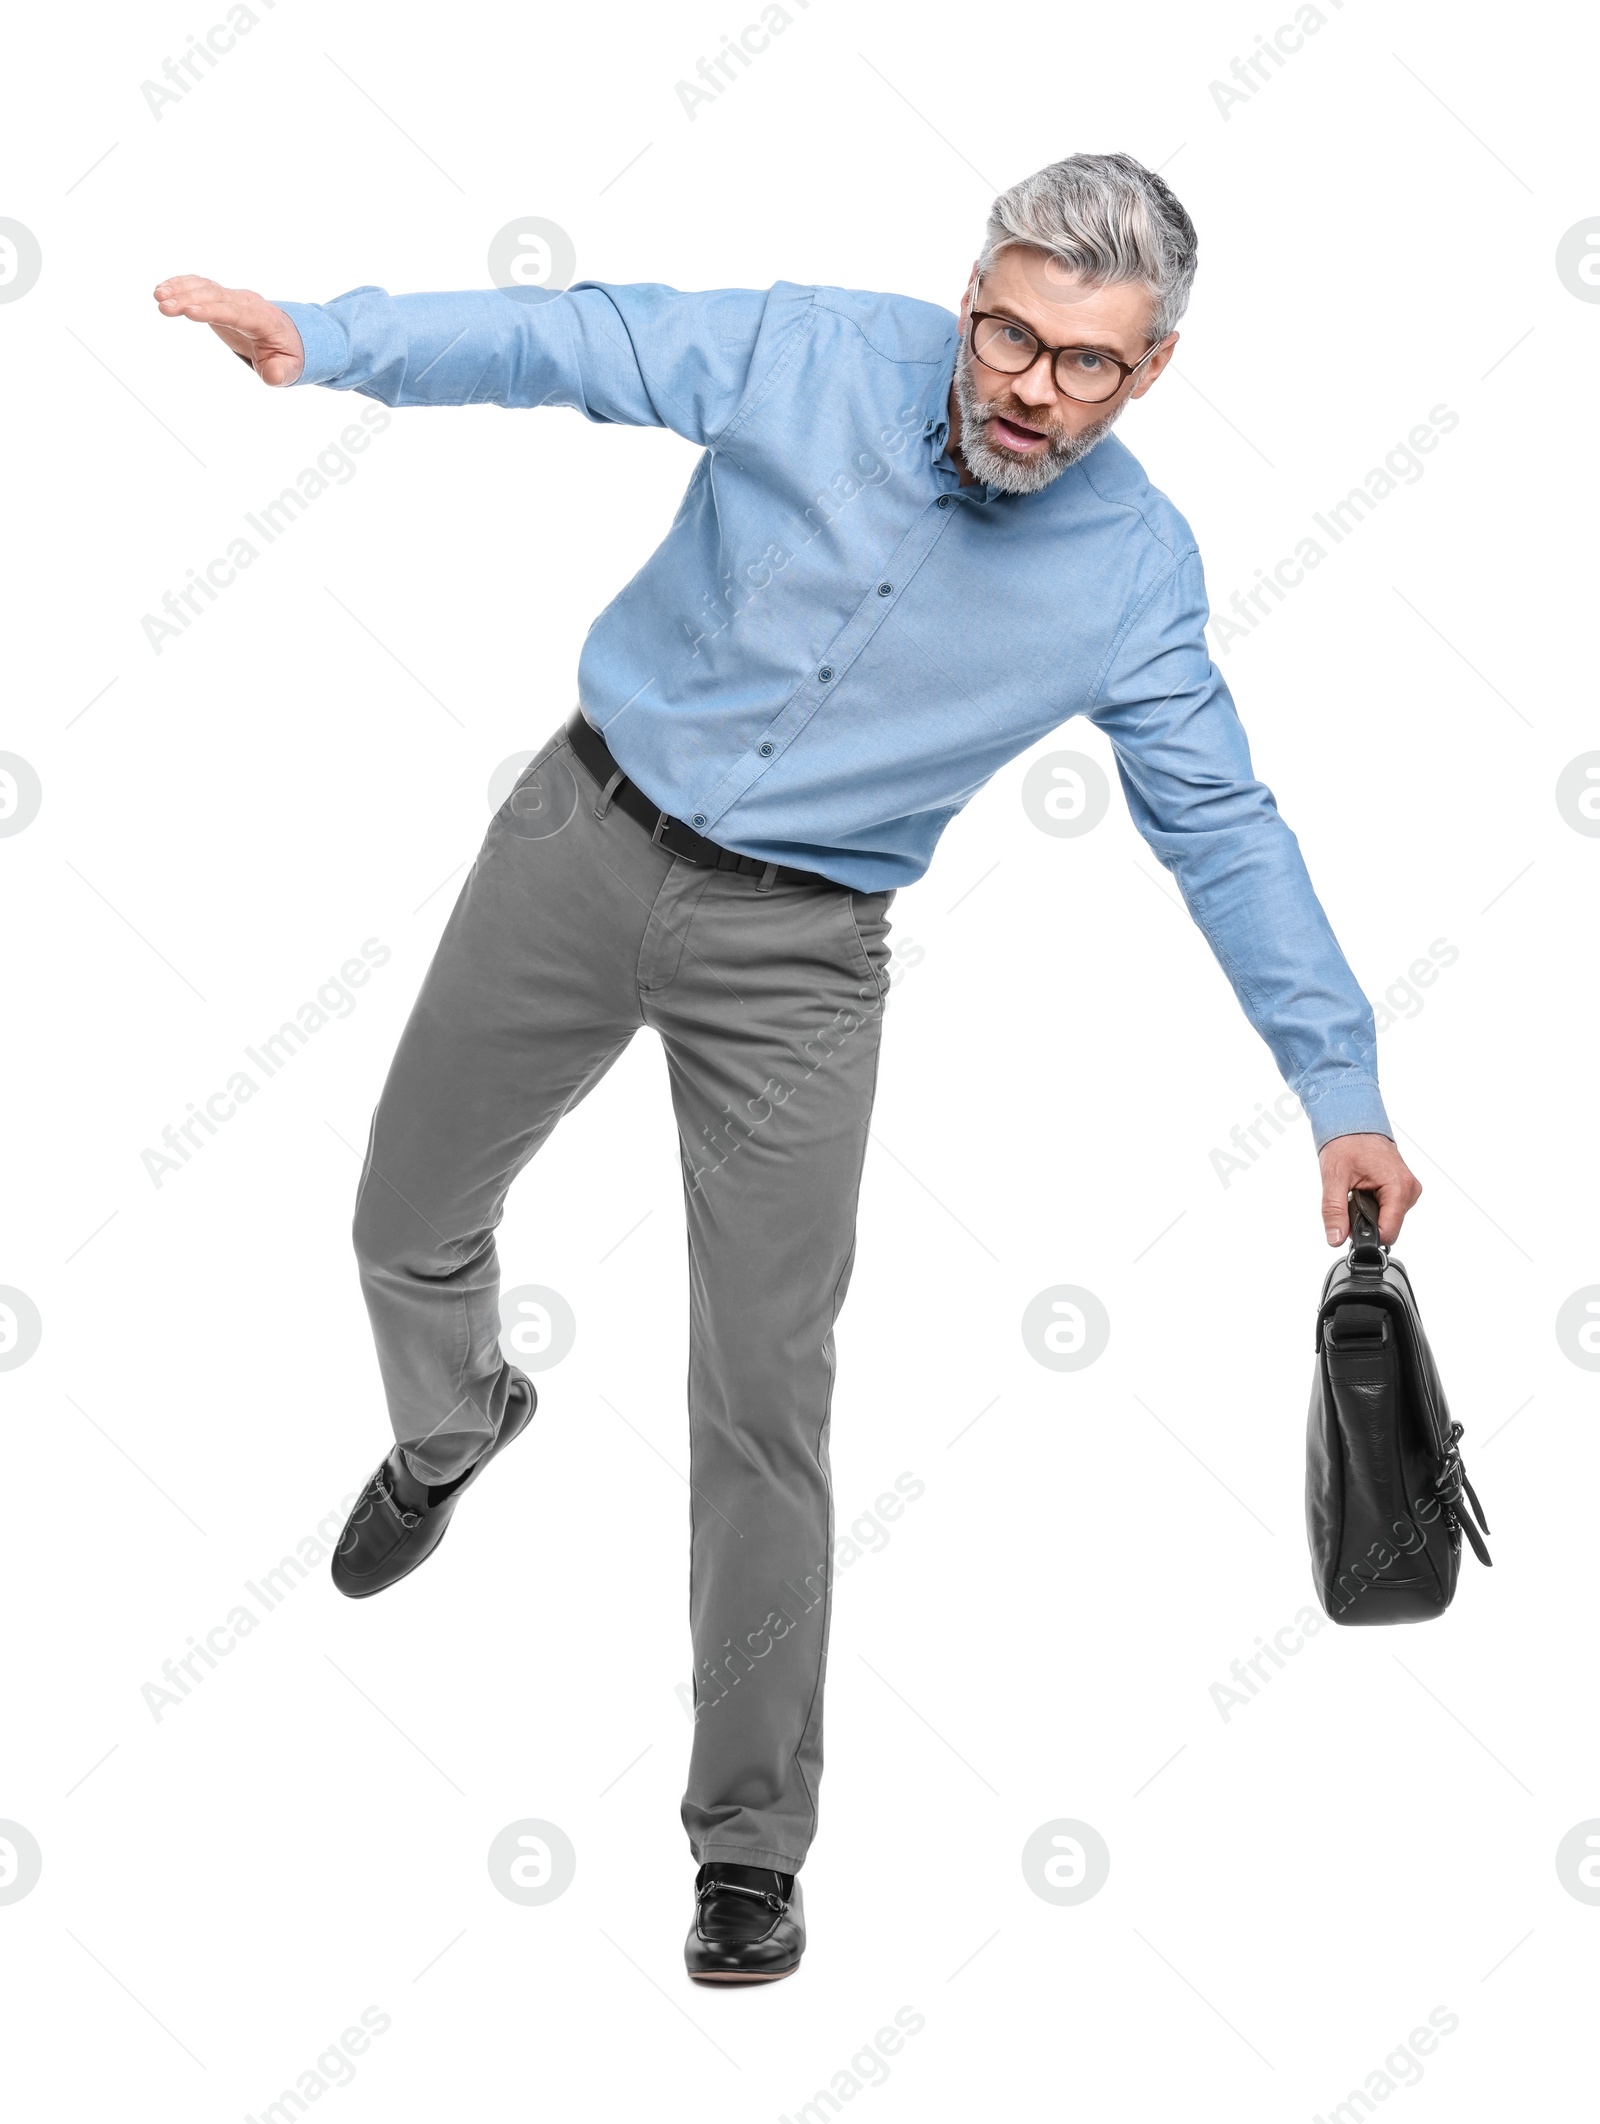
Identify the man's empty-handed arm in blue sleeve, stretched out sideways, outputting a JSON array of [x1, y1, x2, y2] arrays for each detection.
[[155, 276, 810, 444]]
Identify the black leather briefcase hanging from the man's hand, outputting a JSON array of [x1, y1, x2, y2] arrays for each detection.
[[1305, 1189, 1490, 1623]]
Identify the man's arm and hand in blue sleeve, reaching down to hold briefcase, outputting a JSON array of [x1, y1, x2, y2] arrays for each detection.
[[1092, 552, 1422, 1247]]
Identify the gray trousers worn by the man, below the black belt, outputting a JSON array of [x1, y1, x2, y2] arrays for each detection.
[[355, 737, 892, 1873]]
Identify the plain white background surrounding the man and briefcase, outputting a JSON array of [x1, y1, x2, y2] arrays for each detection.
[[0, 0, 1600, 2124]]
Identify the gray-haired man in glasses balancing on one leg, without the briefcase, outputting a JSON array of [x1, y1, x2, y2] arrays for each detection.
[[155, 155, 1419, 1982]]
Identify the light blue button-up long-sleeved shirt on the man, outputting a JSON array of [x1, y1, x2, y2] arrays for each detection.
[[283, 280, 1392, 1145]]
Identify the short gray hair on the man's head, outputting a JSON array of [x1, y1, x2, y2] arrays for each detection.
[[977, 155, 1198, 340]]
